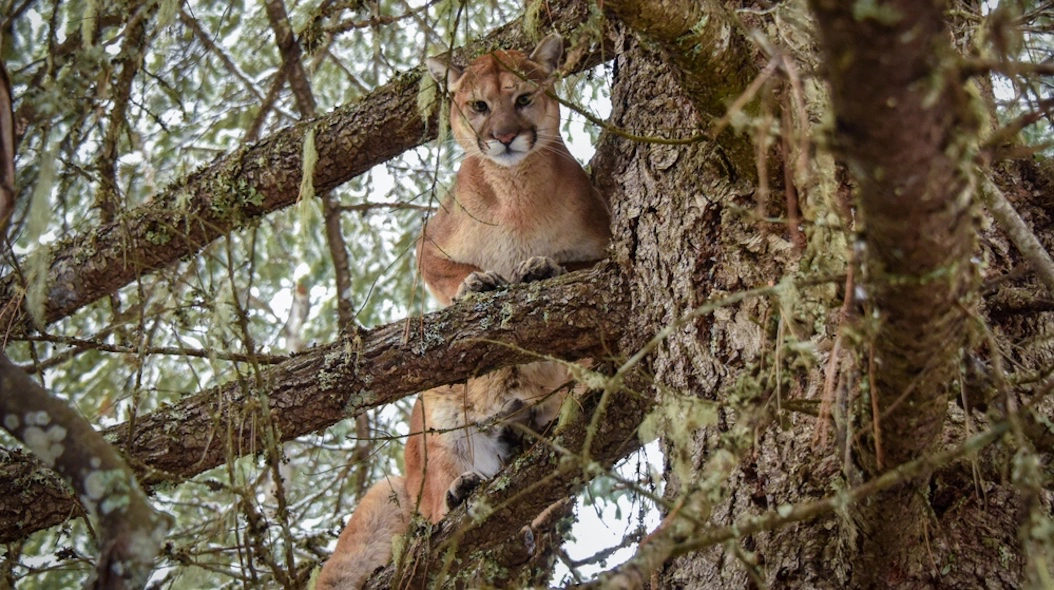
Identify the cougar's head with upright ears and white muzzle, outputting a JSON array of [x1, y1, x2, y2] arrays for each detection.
[[427, 34, 564, 168]]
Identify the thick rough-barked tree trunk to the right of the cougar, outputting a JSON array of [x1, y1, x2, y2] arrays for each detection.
[[601, 3, 1051, 589]]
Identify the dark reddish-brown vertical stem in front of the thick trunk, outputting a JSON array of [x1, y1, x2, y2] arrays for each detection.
[[811, 0, 977, 587]]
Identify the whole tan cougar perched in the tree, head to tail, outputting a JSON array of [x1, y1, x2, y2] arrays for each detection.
[[318, 35, 610, 590]]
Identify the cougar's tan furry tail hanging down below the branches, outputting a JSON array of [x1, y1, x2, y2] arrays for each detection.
[[315, 477, 412, 590]]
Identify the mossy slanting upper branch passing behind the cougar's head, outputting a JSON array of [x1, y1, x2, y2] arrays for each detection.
[[0, 0, 610, 334]]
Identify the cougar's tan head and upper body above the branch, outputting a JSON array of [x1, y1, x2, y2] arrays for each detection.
[[417, 37, 611, 304]]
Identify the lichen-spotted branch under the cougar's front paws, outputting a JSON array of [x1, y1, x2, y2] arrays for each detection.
[[0, 263, 628, 543]]
